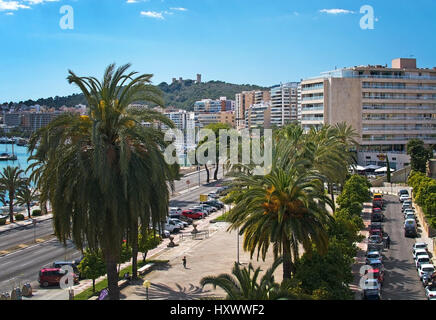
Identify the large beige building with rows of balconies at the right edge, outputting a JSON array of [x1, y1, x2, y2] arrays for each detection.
[[301, 58, 436, 169]]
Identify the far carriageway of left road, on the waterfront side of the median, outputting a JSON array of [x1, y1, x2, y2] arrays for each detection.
[[0, 219, 53, 251]]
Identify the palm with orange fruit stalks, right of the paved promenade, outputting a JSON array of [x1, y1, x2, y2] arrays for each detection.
[[227, 142, 333, 279]]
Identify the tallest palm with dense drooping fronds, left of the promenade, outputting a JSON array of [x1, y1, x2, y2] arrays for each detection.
[[29, 64, 177, 300]]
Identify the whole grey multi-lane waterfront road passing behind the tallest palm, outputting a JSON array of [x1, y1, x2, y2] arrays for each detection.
[[0, 171, 225, 292]]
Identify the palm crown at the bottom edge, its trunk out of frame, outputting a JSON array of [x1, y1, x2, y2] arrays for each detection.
[[200, 259, 304, 300]]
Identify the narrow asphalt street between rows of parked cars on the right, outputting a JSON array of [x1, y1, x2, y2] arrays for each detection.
[[382, 196, 426, 300]]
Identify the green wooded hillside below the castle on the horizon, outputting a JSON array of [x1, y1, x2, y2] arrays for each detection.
[[9, 80, 267, 110]]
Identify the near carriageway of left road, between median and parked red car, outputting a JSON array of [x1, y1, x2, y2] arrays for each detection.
[[0, 240, 81, 291]]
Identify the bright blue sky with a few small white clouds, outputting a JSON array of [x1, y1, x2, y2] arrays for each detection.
[[0, 0, 436, 103]]
